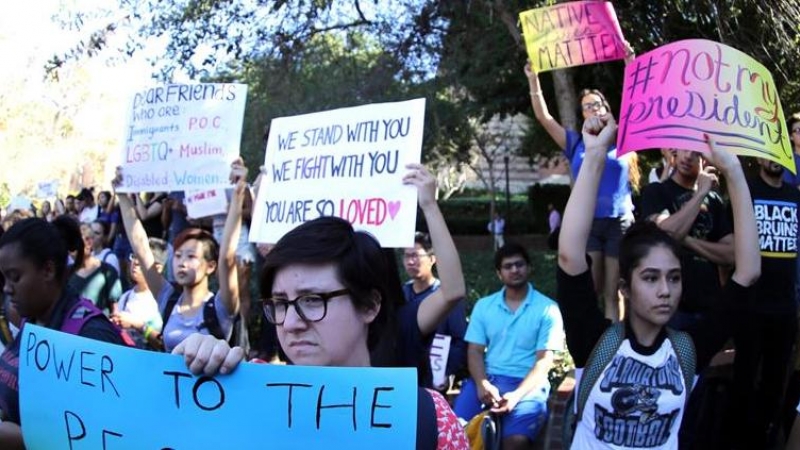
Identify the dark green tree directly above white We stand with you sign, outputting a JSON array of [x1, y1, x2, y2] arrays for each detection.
[[217, 32, 408, 172]]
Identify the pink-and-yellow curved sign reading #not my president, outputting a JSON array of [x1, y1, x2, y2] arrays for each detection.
[[617, 39, 795, 173]]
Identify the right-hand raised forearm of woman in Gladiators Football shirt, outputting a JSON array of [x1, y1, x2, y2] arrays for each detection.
[[706, 136, 761, 286]]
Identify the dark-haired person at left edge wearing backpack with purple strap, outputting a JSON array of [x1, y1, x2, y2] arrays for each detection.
[[0, 217, 126, 450]]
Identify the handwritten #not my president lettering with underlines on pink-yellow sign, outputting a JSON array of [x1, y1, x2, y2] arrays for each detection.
[[620, 43, 784, 152]]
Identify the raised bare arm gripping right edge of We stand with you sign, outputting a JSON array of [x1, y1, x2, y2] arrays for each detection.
[[403, 164, 466, 336]]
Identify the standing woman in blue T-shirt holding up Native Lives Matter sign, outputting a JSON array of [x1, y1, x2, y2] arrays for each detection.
[[525, 60, 641, 321]]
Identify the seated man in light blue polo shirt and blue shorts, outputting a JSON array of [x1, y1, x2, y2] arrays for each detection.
[[454, 243, 564, 450]]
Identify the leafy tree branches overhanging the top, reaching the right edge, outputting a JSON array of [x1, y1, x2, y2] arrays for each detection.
[[50, 0, 800, 162]]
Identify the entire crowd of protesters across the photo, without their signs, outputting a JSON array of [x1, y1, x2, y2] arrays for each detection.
[[0, 66, 800, 450]]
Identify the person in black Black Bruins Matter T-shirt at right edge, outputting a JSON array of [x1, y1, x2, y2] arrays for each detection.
[[731, 158, 800, 448]]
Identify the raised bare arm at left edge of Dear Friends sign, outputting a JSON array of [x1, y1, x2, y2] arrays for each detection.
[[111, 168, 167, 296]]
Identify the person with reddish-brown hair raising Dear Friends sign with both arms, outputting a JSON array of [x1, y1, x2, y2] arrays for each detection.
[[113, 159, 242, 352]]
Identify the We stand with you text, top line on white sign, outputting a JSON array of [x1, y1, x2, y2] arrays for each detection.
[[278, 117, 411, 151]]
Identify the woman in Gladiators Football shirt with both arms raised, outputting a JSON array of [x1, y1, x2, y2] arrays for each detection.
[[556, 115, 761, 449]]
